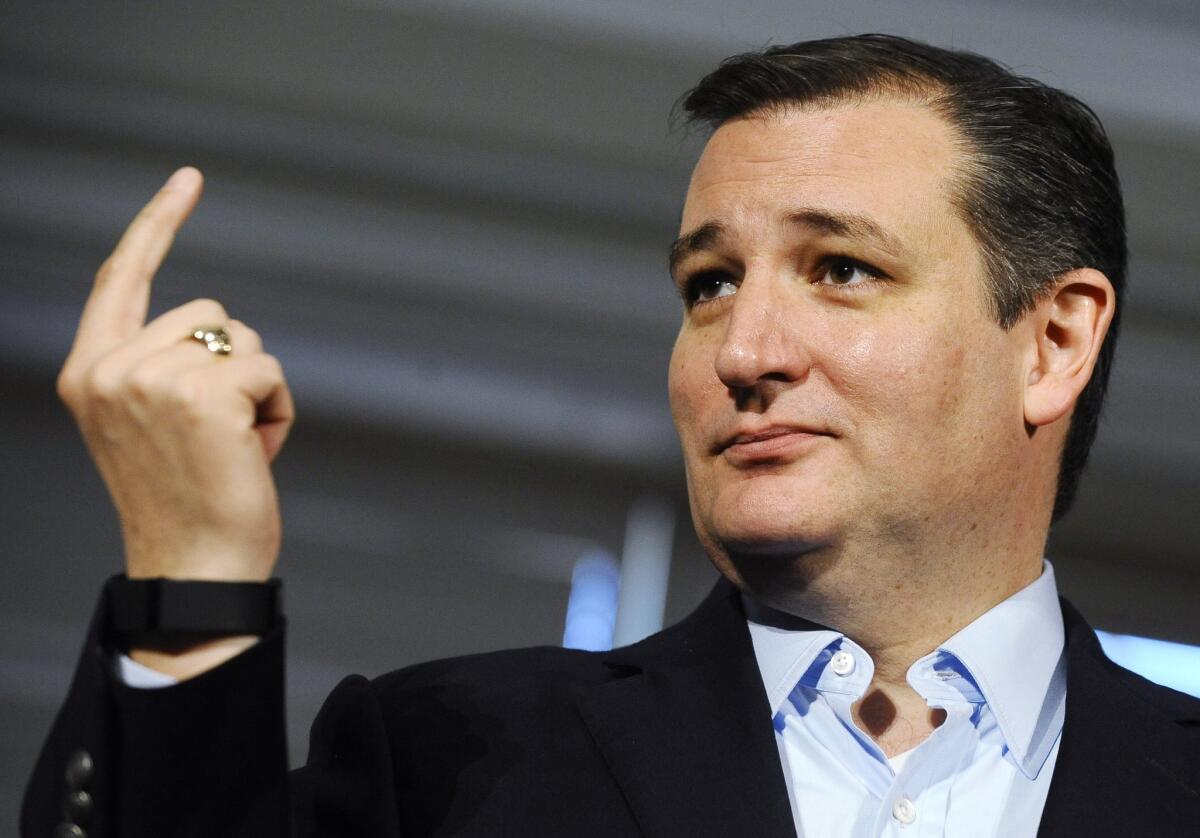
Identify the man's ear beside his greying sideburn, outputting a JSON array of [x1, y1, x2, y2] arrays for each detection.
[[1025, 268, 1117, 427]]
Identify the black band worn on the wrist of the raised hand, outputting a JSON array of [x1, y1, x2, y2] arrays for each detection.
[[106, 576, 282, 644]]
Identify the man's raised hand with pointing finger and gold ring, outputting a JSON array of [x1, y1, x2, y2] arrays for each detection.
[[58, 168, 293, 588]]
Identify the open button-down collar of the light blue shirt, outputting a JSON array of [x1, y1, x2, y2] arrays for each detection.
[[743, 562, 1066, 777]]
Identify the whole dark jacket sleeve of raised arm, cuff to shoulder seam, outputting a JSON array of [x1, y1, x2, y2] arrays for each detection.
[[20, 573, 422, 838]]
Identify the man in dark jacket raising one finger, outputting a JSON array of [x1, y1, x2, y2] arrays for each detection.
[[23, 36, 1200, 836]]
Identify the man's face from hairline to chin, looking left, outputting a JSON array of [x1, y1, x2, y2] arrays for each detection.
[[670, 101, 1025, 588]]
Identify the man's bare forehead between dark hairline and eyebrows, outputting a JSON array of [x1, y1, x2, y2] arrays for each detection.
[[680, 98, 961, 245]]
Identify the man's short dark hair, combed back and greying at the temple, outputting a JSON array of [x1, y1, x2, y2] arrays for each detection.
[[680, 35, 1127, 521]]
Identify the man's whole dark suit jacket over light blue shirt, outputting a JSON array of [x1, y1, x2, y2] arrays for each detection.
[[22, 582, 1200, 838]]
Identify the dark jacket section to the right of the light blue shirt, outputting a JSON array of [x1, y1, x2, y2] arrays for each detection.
[[1038, 603, 1200, 838]]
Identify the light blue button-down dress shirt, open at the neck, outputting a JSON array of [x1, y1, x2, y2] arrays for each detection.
[[746, 562, 1066, 838]]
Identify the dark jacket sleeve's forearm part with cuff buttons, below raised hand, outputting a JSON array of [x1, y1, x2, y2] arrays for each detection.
[[20, 578, 290, 838]]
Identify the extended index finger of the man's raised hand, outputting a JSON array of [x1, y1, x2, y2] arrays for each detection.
[[72, 166, 204, 357]]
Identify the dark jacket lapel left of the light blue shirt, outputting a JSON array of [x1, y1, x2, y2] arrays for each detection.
[[577, 582, 794, 838]]
